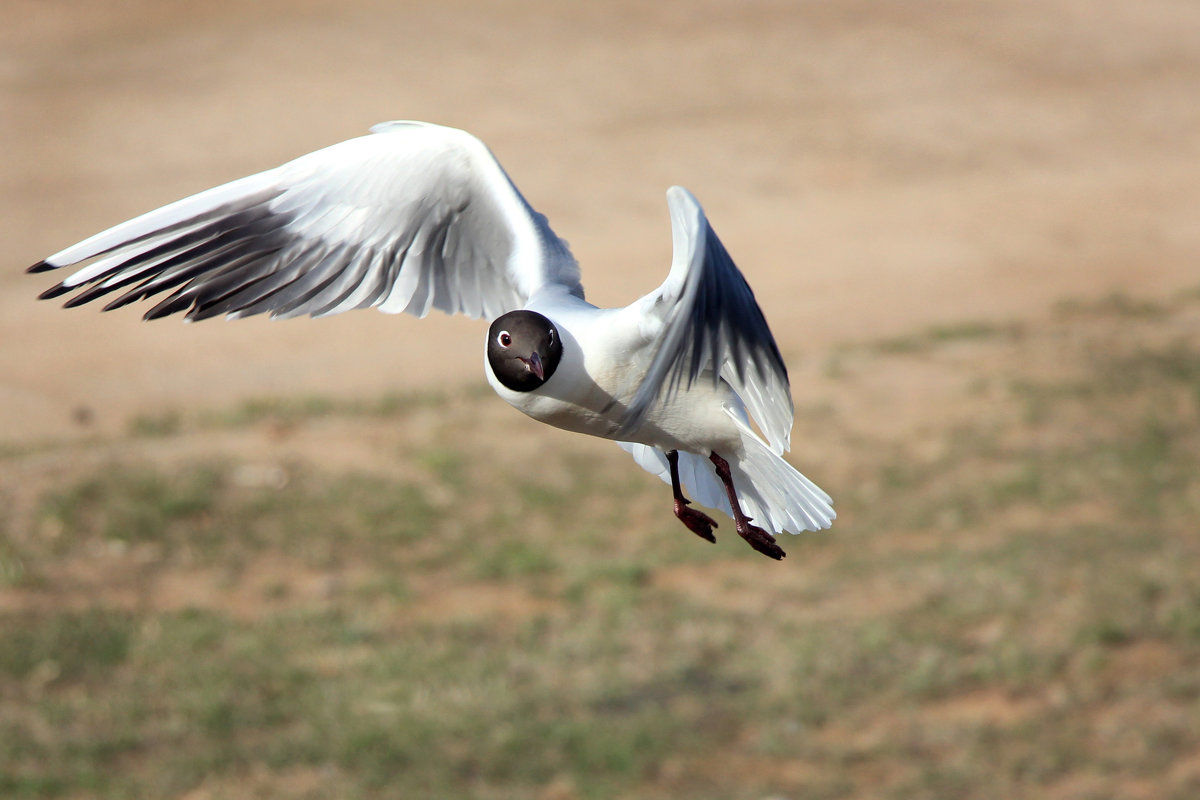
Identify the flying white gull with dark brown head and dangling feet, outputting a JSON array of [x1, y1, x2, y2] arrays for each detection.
[[29, 121, 835, 560]]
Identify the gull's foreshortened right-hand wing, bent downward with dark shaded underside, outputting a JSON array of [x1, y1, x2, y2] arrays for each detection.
[[616, 186, 794, 453]]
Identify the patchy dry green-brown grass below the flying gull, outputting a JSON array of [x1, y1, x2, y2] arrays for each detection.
[[0, 296, 1200, 800]]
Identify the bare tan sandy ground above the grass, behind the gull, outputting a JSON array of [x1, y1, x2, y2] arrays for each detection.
[[0, 0, 1200, 444]]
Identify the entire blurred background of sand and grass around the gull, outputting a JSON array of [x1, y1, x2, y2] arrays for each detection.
[[0, 0, 1200, 800]]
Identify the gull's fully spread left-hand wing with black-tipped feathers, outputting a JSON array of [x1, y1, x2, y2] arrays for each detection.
[[29, 122, 583, 320]]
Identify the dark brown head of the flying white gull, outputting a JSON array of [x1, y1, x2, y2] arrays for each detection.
[[487, 311, 563, 392]]
